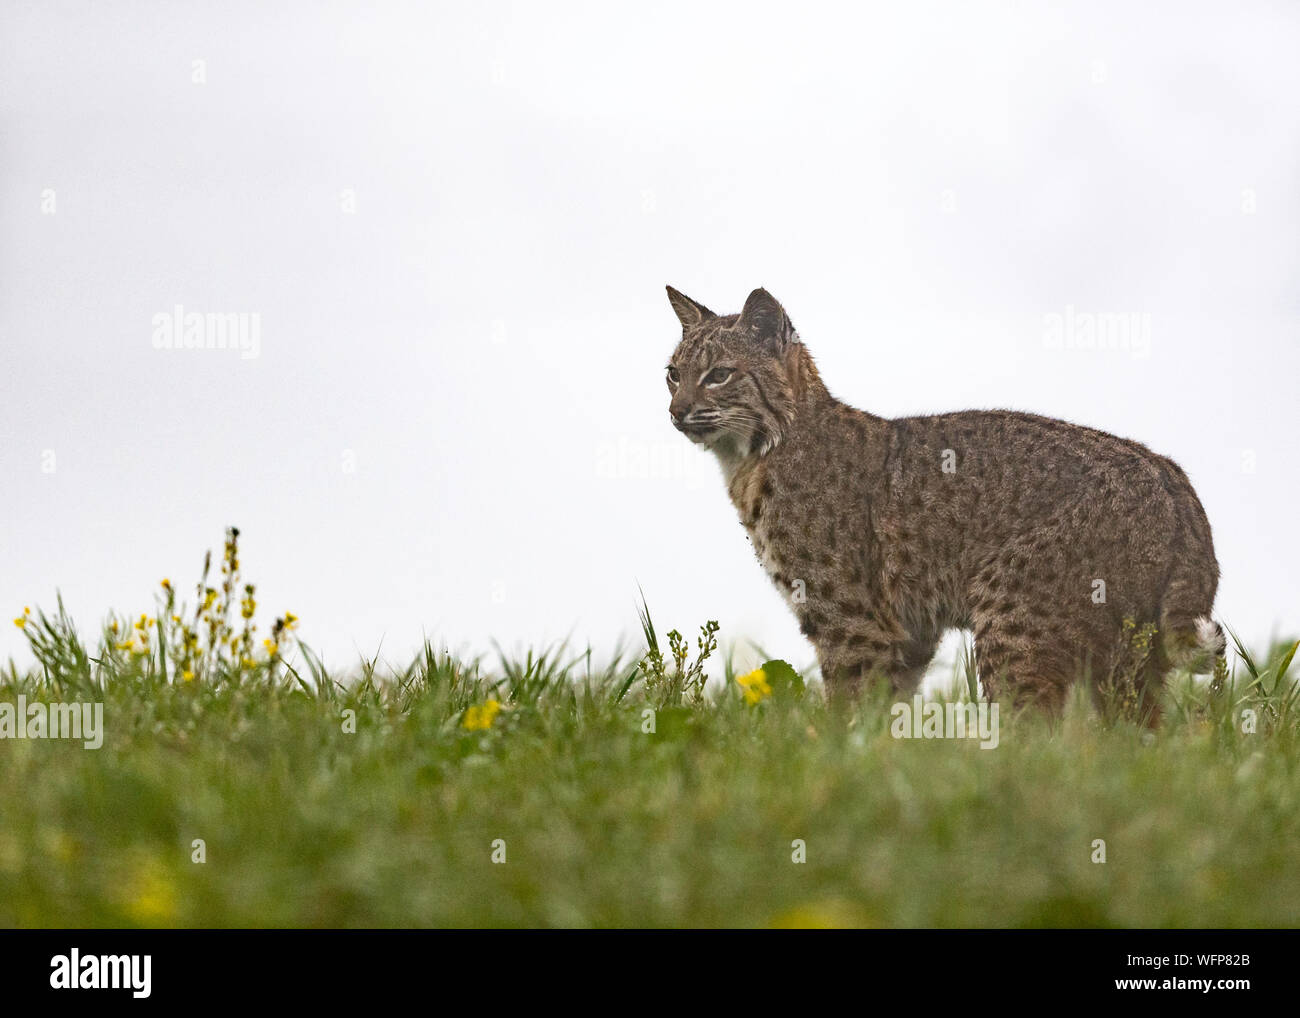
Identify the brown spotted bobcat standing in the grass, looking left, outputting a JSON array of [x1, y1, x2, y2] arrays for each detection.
[[667, 286, 1225, 723]]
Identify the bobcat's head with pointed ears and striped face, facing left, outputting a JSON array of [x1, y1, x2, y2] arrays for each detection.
[[667, 286, 801, 458]]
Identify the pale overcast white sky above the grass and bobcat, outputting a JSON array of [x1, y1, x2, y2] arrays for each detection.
[[0, 0, 1300, 686]]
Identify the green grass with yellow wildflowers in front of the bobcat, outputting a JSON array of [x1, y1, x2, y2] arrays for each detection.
[[0, 533, 1300, 927]]
